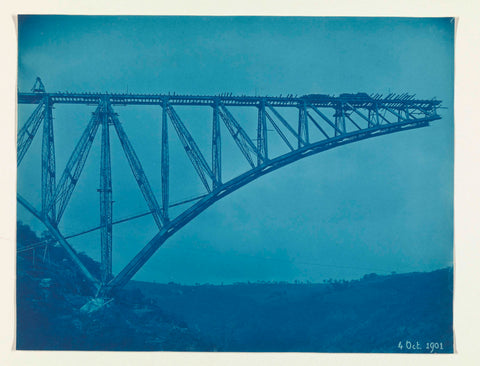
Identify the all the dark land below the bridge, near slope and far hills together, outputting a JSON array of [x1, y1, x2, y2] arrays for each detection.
[[17, 224, 453, 353]]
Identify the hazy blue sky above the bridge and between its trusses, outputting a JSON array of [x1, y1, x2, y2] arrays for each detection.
[[18, 16, 454, 284]]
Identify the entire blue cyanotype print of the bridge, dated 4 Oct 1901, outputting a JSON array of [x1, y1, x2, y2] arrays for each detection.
[[15, 15, 455, 354]]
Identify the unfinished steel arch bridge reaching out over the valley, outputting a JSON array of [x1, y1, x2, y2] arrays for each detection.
[[17, 78, 441, 297]]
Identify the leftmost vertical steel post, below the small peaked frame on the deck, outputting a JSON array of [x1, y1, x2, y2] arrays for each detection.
[[42, 97, 56, 222]]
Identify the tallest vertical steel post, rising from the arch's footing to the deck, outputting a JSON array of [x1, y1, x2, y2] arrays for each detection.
[[99, 98, 112, 283]]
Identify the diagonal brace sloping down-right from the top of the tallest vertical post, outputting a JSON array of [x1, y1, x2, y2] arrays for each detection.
[[108, 105, 166, 229]]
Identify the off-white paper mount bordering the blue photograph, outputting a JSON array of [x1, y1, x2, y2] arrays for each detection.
[[0, 0, 480, 366]]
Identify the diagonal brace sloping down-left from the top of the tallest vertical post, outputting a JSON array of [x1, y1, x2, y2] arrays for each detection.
[[50, 106, 101, 224]]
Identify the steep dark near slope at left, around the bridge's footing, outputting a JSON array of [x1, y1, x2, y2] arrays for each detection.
[[16, 223, 213, 351]]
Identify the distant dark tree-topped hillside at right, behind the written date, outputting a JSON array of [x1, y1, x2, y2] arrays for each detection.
[[129, 269, 453, 352]]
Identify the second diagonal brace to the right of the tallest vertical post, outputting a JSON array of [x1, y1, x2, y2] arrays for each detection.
[[166, 105, 217, 192]]
